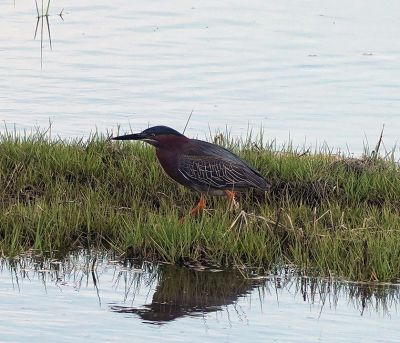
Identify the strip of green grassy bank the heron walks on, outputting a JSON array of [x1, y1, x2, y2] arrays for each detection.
[[0, 133, 400, 281]]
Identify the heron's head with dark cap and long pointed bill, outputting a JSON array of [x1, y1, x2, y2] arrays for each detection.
[[112, 126, 188, 147]]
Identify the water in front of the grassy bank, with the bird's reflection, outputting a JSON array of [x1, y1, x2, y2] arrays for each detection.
[[0, 252, 400, 342]]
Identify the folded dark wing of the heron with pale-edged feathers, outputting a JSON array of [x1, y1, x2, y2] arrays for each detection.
[[178, 155, 265, 189]]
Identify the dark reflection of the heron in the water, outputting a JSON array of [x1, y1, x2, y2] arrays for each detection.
[[111, 266, 265, 323]]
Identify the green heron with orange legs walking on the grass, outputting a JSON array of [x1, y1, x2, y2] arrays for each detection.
[[112, 126, 269, 214]]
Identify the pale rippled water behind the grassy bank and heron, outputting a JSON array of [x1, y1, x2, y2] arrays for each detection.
[[0, 0, 400, 154]]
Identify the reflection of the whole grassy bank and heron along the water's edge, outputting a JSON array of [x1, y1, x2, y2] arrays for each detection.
[[0, 252, 400, 324]]
